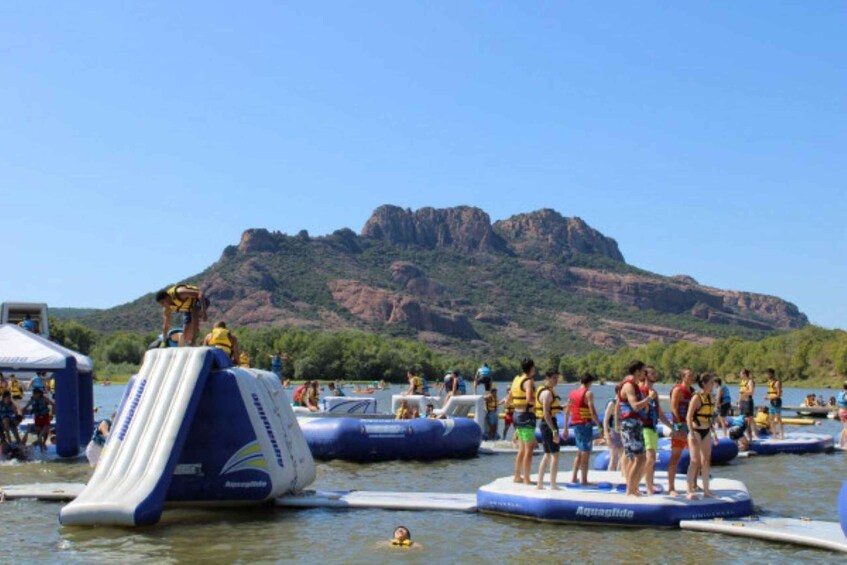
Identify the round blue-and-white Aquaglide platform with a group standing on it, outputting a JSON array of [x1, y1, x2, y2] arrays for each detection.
[[476, 471, 753, 528]]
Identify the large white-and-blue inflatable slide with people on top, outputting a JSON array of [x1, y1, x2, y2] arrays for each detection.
[[60, 347, 315, 526]]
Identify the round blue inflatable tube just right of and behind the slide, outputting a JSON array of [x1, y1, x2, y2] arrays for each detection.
[[298, 418, 482, 463]]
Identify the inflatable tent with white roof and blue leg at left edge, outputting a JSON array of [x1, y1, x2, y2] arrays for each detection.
[[0, 324, 94, 457]]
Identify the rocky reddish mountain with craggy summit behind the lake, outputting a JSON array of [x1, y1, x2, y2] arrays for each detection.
[[78, 206, 808, 354]]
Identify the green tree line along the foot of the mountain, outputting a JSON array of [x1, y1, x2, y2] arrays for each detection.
[[51, 320, 847, 388]]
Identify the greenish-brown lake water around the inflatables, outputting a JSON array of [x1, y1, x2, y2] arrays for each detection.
[[0, 383, 847, 564]]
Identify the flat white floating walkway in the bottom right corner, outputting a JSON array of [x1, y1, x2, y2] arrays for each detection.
[[679, 516, 847, 553]]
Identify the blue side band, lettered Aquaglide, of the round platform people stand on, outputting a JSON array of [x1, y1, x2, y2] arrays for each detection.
[[476, 489, 753, 528]]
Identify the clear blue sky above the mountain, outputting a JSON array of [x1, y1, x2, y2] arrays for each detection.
[[0, 0, 847, 328]]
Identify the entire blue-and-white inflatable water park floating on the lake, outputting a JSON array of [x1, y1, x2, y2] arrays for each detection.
[[0, 308, 847, 551]]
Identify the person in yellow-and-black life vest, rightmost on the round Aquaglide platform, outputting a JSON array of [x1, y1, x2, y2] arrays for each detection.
[[686, 373, 718, 500]]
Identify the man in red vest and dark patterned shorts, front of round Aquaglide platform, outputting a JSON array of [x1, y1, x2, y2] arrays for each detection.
[[618, 361, 658, 496]]
